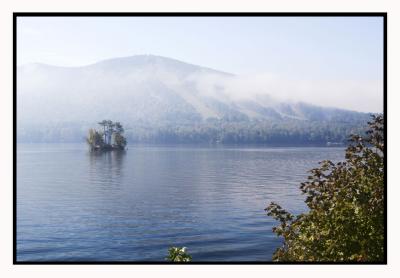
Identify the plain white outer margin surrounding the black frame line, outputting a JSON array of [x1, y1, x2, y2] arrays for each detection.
[[0, 0, 400, 278]]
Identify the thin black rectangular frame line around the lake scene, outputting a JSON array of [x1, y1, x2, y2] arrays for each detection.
[[13, 12, 387, 265]]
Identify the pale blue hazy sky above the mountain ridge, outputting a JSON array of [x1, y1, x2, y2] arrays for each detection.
[[17, 17, 383, 112]]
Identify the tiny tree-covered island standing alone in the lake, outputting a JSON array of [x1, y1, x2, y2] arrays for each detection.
[[86, 120, 126, 151]]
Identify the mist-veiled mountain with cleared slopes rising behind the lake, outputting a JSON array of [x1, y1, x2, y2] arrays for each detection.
[[17, 55, 369, 142]]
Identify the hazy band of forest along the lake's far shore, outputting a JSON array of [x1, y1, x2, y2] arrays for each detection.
[[18, 116, 367, 145]]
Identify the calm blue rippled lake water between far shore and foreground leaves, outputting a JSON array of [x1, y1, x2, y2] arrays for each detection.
[[17, 144, 344, 261]]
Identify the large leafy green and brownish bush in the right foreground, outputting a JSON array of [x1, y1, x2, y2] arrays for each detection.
[[265, 115, 385, 262]]
